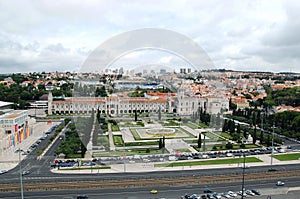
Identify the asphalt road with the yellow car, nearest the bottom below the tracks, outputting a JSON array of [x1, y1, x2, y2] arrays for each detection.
[[0, 178, 300, 199]]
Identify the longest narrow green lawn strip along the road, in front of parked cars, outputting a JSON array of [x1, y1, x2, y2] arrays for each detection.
[[154, 157, 262, 167]]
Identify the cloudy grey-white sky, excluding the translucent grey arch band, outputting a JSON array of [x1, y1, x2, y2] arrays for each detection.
[[0, 0, 300, 73]]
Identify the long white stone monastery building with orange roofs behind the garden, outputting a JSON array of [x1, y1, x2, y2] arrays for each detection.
[[48, 91, 229, 116]]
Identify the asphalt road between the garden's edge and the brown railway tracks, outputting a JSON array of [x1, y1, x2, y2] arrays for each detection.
[[0, 159, 300, 184]]
